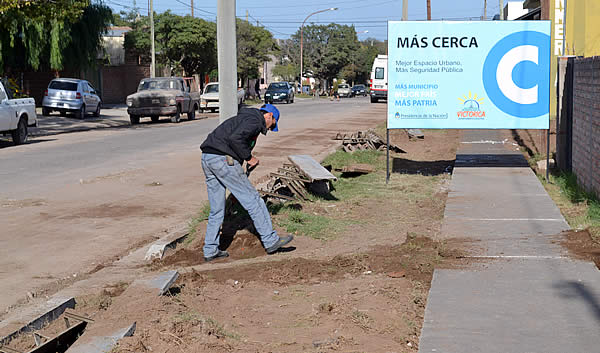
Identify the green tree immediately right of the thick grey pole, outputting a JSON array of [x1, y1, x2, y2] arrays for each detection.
[[237, 19, 278, 89]]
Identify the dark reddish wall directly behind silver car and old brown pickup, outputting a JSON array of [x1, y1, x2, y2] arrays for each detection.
[[102, 65, 150, 104]]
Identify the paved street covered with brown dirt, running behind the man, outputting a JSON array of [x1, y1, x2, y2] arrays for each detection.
[[0, 98, 385, 309]]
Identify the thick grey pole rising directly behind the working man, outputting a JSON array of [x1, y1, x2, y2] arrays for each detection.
[[217, 0, 238, 123]]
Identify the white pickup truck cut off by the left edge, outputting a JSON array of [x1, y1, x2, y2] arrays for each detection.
[[0, 81, 37, 145]]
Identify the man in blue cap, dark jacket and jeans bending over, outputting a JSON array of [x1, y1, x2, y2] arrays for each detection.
[[200, 104, 293, 262]]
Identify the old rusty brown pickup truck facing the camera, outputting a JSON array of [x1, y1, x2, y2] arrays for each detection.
[[125, 77, 200, 125]]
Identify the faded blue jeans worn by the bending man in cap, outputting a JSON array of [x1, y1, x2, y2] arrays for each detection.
[[202, 153, 279, 257]]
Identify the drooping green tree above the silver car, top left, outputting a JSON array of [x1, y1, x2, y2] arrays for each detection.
[[0, 0, 112, 73]]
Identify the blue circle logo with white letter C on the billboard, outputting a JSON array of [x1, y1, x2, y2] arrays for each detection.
[[483, 31, 550, 118]]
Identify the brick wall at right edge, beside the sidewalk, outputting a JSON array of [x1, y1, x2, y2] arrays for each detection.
[[572, 57, 600, 197]]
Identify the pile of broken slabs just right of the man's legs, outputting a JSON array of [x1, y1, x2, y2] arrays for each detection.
[[259, 155, 337, 201]]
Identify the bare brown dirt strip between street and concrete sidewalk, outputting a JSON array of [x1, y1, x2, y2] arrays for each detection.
[[17, 125, 469, 352]]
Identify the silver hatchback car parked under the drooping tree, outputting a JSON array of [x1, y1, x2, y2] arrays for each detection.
[[42, 78, 102, 119]]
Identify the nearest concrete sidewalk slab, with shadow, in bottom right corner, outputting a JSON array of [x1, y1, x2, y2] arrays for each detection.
[[419, 259, 600, 353]]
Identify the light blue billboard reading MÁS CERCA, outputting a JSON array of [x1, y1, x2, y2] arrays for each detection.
[[387, 21, 551, 129]]
